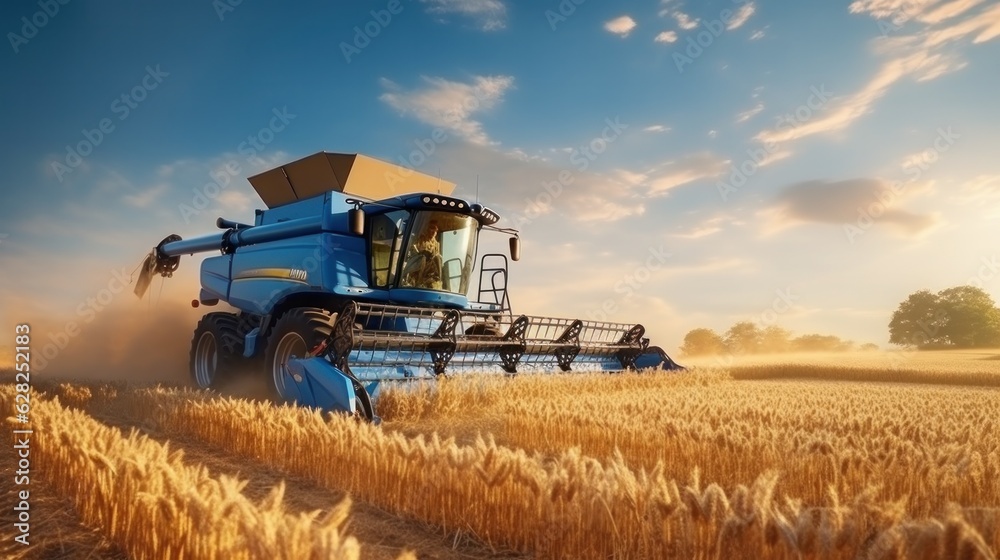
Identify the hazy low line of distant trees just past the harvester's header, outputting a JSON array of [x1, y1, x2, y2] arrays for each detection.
[[681, 321, 878, 356]]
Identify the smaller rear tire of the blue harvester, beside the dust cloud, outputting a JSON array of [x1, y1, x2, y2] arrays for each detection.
[[190, 312, 242, 389]]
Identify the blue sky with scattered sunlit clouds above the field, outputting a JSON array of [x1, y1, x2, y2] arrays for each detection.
[[0, 0, 1000, 376]]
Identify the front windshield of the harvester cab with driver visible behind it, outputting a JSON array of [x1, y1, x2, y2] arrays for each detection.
[[400, 211, 479, 295]]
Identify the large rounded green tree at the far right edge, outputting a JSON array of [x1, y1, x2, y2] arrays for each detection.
[[889, 286, 1000, 348]]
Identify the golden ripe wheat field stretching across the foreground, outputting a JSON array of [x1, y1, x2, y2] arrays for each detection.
[[0, 352, 1000, 559]]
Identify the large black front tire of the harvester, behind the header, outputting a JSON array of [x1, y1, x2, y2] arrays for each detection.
[[264, 307, 337, 399]]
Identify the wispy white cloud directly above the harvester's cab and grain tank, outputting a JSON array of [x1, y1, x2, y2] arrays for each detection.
[[379, 76, 514, 144]]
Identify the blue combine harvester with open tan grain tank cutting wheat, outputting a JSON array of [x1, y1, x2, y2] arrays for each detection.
[[135, 152, 682, 422]]
